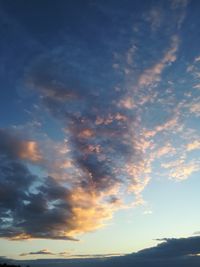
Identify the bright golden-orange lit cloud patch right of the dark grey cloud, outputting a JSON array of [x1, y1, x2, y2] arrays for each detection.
[[67, 188, 121, 236]]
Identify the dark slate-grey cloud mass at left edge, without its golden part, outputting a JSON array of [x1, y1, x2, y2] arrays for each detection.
[[0, 130, 79, 240]]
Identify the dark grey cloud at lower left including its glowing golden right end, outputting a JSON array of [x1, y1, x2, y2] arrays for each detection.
[[0, 129, 130, 240]]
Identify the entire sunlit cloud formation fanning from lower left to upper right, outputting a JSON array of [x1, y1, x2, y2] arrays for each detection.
[[0, 1, 199, 244]]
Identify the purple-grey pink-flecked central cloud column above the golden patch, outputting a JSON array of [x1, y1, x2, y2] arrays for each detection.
[[27, 51, 142, 197]]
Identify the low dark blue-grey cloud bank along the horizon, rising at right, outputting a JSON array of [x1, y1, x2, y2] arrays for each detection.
[[16, 236, 200, 267]]
